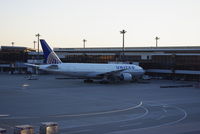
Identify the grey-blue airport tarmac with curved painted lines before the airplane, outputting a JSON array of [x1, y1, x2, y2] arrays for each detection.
[[0, 74, 200, 134]]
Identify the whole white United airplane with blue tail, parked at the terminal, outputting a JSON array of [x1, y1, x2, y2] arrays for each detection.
[[27, 39, 145, 83]]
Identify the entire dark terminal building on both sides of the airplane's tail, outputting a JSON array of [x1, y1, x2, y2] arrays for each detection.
[[0, 46, 200, 80]]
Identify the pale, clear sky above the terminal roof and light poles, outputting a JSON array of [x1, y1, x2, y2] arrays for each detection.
[[0, 0, 200, 48]]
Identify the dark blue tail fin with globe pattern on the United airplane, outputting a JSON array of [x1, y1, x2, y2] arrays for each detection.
[[40, 39, 62, 64]]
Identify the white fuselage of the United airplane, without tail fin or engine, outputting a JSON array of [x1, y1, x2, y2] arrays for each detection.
[[39, 63, 144, 78]]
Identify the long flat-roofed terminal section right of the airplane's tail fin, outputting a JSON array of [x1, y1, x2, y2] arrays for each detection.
[[54, 46, 200, 80]]
